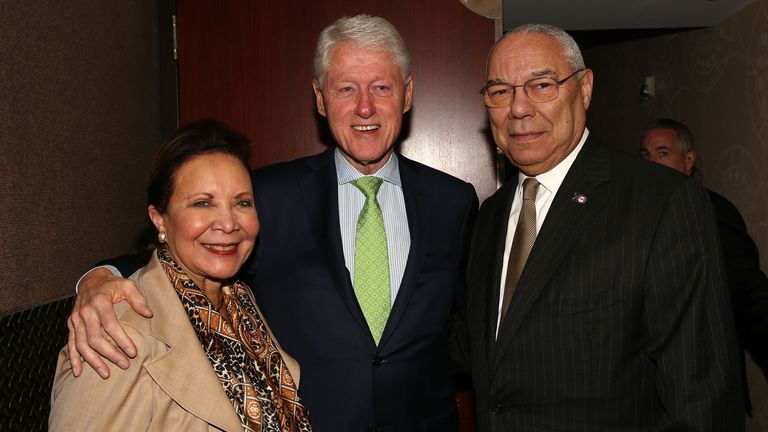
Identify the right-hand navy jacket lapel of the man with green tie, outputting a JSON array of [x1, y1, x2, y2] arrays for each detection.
[[379, 155, 430, 347]]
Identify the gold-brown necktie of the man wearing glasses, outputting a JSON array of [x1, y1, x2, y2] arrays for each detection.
[[501, 177, 539, 321]]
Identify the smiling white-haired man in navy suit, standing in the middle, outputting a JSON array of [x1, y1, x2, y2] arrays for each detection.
[[70, 15, 477, 432]]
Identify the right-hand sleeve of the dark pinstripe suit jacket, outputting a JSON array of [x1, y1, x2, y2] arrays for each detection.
[[643, 179, 744, 431]]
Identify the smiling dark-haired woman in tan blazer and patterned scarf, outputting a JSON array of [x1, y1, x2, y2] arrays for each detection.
[[49, 120, 311, 432]]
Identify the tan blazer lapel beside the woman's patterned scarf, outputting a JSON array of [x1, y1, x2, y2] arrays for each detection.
[[138, 256, 242, 431]]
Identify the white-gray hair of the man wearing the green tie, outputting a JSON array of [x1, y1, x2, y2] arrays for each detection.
[[315, 14, 411, 88]]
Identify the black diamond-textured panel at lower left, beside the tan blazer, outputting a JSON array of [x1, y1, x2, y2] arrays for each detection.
[[0, 296, 75, 432]]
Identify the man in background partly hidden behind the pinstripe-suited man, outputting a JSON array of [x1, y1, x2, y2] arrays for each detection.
[[640, 119, 768, 404]]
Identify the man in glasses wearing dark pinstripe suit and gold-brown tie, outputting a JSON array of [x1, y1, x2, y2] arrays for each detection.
[[456, 25, 744, 431]]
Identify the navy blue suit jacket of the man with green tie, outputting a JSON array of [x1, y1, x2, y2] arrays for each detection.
[[244, 148, 477, 432]]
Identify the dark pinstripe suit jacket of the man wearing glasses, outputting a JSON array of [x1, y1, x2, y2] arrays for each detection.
[[454, 135, 744, 431]]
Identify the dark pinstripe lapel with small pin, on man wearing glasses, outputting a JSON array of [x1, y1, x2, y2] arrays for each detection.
[[491, 137, 610, 370]]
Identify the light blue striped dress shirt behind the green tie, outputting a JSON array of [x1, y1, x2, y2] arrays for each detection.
[[335, 148, 411, 303]]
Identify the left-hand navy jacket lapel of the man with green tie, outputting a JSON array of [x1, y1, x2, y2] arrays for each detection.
[[299, 147, 373, 342]]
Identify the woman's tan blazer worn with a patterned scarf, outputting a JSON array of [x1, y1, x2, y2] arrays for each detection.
[[48, 254, 299, 431]]
